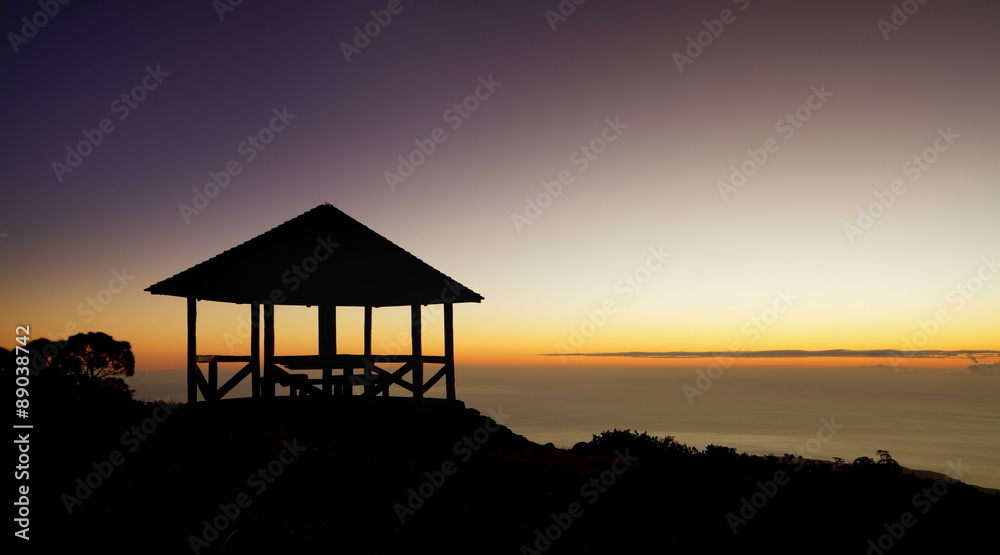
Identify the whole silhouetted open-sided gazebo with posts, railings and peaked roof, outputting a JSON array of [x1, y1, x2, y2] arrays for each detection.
[[146, 204, 483, 403]]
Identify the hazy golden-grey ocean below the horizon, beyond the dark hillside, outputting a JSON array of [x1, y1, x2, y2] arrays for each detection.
[[129, 361, 1000, 488]]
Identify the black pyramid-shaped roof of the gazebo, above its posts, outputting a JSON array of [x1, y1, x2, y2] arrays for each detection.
[[146, 204, 483, 306]]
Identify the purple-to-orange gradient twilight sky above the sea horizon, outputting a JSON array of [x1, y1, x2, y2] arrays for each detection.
[[0, 0, 1000, 369]]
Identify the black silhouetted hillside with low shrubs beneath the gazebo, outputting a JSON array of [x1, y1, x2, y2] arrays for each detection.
[[0, 338, 1000, 554]]
